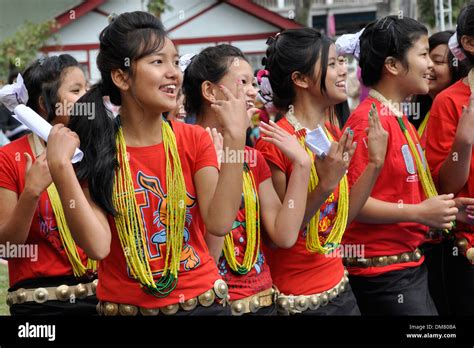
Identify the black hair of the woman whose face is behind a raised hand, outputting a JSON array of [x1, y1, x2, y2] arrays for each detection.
[[183, 44, 248, 118]]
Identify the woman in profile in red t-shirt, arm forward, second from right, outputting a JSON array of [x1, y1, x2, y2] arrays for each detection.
[[344, 16, 466, 315]]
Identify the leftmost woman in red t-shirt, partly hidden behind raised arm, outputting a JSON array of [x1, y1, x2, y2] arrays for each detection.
[[0, 54, 97, 315]]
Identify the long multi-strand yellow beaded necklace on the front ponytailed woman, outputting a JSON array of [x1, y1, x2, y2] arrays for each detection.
[[113, 119, 186, 297]]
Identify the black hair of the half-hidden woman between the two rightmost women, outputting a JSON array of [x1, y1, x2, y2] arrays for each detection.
[[409, 30, 468, 128]]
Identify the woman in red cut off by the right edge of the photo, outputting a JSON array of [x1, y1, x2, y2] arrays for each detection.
[[426, 4, 474, 315]]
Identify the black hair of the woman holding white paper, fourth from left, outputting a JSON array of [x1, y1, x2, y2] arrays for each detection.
[[262, 28, 332, 112]]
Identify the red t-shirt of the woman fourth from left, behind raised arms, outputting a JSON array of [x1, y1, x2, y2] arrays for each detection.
[[256, 117, 344, 295]]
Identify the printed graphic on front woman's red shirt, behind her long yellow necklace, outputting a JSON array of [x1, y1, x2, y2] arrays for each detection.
[[135, 171, 200, 275]]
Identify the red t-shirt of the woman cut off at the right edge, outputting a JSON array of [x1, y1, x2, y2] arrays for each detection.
[[426, 80, 474, 247]]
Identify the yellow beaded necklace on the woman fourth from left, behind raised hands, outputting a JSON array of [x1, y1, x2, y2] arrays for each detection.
[[286, 111, 349, 254]]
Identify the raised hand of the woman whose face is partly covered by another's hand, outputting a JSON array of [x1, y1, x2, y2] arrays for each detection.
[[260, 120, 311, 166]]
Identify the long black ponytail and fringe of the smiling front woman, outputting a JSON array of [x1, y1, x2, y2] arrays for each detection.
[[70, 11, 166, 215]]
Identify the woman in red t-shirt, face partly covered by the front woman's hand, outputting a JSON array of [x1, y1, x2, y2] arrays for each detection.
[[183, 45, 311, 315]]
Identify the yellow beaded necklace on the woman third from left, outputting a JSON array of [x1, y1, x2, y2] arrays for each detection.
[[223, 163, 260, 274]]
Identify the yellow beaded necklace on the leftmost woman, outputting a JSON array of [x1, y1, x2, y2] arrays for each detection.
[[32, 133, 97, 278]]
